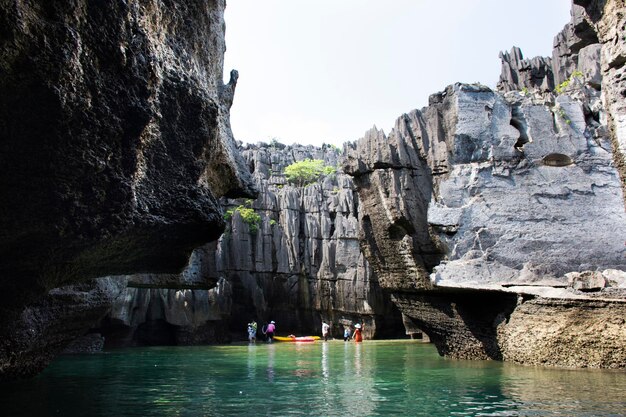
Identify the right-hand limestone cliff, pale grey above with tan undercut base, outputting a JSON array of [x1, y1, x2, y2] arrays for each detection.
[[344, 1, 626, 368]]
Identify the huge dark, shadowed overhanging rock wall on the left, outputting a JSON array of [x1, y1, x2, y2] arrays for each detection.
[[0, 0, 255, 374]]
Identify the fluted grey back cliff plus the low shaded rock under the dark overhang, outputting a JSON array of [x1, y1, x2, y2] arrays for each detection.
[[99, 142, 404, 344]]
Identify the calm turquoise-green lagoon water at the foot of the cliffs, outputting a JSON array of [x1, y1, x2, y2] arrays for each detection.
[[0, 341, 626, 416]]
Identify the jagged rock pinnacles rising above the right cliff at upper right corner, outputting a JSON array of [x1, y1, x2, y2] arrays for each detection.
[[498, 0, 626, 203]]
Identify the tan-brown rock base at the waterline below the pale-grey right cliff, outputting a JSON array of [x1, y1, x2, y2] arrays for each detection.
[[497, 297, 626, 368]]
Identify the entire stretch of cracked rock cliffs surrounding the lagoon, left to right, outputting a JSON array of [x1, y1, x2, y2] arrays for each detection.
[[0, 0, 626, 379]]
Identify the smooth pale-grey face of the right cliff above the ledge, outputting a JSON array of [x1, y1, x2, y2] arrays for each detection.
[[433, 89, 626, 287]]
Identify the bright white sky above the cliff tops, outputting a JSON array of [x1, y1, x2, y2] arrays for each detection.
[[224, 0, 571, 145]]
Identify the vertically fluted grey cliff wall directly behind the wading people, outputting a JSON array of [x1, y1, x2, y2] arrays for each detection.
[[216, 144, 401, 337]]
